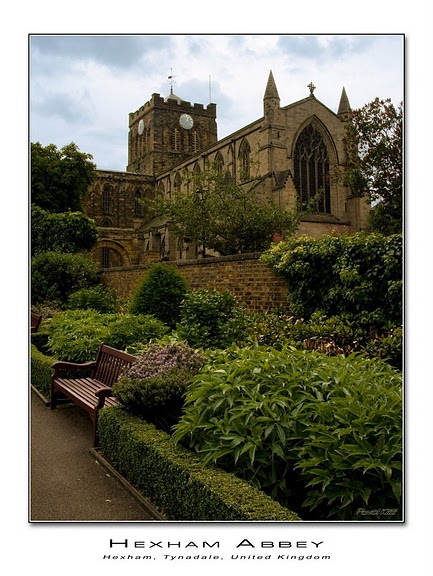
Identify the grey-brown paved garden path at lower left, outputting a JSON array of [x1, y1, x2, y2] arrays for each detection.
[[29, 392, 159, 522]]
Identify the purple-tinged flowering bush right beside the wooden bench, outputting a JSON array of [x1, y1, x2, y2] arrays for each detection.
[[113, 342, 206, 432]]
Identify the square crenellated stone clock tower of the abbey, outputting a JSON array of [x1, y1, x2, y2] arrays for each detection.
[[126, 87, 218, 176]]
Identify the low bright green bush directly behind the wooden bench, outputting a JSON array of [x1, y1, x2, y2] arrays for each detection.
[[46, 310, 168, 362]]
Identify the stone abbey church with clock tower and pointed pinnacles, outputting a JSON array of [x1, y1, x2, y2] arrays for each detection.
[[83, 72, 370, 268]]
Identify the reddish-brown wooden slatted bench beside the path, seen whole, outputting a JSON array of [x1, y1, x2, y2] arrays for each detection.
[[50, 344, 136, 446]]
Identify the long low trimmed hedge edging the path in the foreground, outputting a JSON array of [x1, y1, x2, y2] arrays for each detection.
[[98, 407, 300, 522]]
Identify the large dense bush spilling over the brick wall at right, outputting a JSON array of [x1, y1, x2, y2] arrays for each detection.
[[261, 232, 402, 326]]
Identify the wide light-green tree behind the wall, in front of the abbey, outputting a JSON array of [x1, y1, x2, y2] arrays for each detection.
[[154, 164, 299, 256]]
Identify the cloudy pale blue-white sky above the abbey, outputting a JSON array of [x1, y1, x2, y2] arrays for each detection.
[[30, 34, 404, 170]]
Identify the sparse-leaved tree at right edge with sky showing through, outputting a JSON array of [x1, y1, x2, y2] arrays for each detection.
[[346, 98, 403, 234]]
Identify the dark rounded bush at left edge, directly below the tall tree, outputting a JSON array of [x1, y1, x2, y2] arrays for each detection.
[[31, 205, 98, 256]]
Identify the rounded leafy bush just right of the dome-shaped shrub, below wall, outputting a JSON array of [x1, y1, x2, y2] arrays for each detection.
[[177, 290, 247, 348]]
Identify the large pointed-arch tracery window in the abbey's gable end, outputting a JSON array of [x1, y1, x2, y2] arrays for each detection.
[[294, 124, 331, 214]]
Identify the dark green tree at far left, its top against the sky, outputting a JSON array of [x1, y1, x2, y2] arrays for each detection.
[[31, 142, 96, 212]]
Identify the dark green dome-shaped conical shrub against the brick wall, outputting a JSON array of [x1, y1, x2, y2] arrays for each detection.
[[130, 263, 188, 327]]
